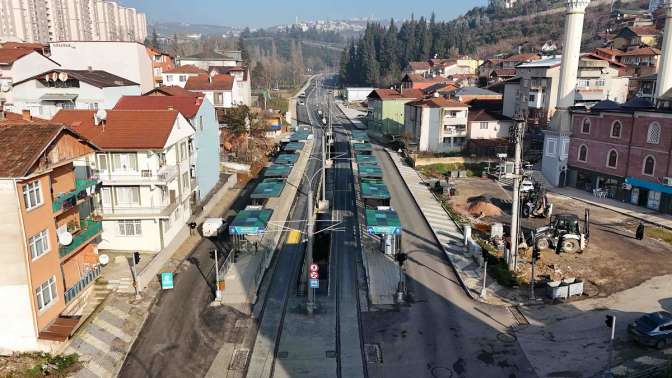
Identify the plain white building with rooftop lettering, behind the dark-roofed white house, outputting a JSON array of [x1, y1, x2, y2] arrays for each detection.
[[49, 41, 154, 93]]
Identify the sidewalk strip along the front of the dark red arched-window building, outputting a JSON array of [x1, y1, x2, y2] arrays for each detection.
[[548, 187, 672, 230]]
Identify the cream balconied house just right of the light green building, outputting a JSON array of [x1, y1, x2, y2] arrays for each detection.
[[404, 97, 469, 153]]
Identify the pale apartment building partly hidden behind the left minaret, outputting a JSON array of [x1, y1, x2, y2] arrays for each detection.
[[503, 56, 629, 127]]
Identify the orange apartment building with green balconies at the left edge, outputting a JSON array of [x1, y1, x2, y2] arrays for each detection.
[[0, 122, 101, 354]]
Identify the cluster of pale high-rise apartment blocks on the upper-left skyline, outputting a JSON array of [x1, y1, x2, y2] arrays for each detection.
[[0, 0, 147, 43]]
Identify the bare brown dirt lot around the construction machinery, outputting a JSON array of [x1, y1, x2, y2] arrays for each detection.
[[450, 178, 672, 297]]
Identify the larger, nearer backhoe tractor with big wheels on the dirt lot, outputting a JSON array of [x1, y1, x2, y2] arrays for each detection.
[[534, 209, 590, 253]]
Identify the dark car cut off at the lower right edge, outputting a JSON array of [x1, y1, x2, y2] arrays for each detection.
[[628, 311, 672, 349]]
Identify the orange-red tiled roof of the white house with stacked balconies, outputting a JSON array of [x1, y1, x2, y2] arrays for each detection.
[[52, 110, 179, 150]]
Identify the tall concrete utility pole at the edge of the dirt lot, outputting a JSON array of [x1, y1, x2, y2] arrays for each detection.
[[506, 115, 525, 272]]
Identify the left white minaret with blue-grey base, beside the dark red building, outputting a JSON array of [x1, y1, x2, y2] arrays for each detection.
[[541, 0, 590, 186]]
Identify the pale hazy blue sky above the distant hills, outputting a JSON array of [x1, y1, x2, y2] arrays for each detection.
[[119, 0, 488, 28]]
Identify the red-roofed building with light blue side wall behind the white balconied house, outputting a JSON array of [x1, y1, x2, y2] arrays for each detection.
[[114, 94, 220, 203]]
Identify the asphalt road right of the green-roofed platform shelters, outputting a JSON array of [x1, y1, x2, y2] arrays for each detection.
[[330, 104, 534, 377]]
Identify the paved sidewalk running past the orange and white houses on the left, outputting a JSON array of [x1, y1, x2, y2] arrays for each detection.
[[63, 185, 239, 378]]
